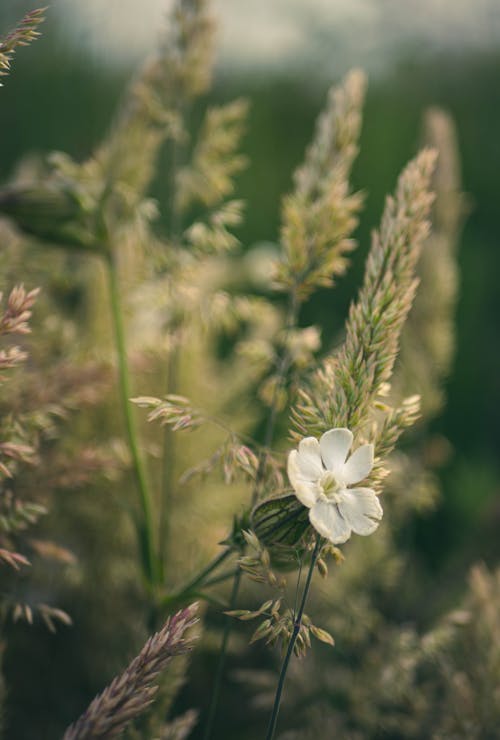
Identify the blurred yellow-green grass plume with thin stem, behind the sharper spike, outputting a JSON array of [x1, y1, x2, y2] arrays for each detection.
[[205, 72, 365, 740]]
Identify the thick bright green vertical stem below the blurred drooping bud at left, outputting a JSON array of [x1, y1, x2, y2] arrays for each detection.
[[106, 256, 157, 586]]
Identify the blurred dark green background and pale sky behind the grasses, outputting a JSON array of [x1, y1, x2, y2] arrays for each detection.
[[0, 0, 500, 736]]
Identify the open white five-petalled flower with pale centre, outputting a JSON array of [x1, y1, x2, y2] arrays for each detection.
[[288, 429, 383, 545]]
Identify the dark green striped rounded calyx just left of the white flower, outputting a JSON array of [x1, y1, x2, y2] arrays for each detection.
[[251, 494, 309, 547]]
